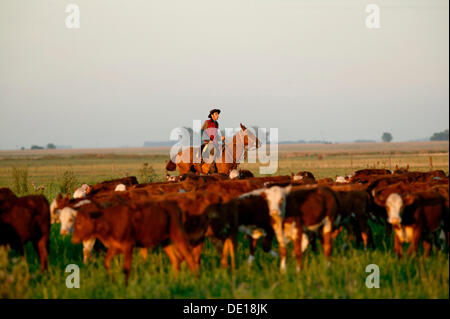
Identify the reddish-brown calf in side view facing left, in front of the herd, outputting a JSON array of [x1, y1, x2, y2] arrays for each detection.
[[72, 201, 198, 284]]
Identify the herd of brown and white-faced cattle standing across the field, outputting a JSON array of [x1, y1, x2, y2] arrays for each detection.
[[0, 168, 449, 282]]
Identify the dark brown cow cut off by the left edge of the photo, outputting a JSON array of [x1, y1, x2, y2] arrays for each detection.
[[0, 195, 50, 272]]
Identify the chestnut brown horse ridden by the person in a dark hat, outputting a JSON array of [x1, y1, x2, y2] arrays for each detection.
[[166, 123, 261, 175]]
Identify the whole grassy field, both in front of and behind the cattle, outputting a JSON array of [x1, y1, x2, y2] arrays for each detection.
[[0, 142, 449, 298]]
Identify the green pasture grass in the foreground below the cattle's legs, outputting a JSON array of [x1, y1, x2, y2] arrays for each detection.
[[2, 225, 449, 299]]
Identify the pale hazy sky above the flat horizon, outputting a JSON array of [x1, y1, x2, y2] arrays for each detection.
[[0, 0, 449, 149]]
